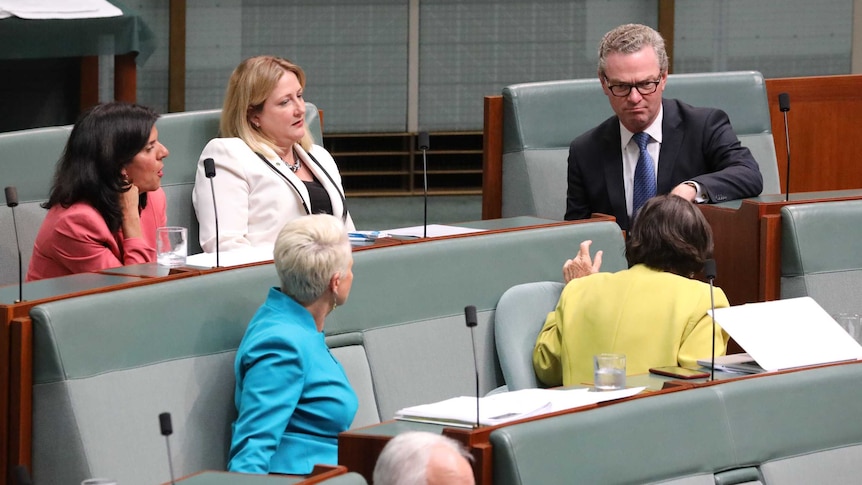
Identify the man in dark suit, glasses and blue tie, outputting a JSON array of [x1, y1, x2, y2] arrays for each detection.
[[565, 24, 763, 230]]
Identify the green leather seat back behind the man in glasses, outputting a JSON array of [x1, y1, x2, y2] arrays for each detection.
[[502, 71, 781, 220]]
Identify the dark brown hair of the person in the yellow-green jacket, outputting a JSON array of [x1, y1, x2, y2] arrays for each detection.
[[626, 194, 713, 277]]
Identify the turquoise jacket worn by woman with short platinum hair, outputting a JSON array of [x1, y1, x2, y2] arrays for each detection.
[[228, 288, 358, 475]]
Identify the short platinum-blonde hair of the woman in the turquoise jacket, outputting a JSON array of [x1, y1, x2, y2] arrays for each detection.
[[273, 214, 352, 303]]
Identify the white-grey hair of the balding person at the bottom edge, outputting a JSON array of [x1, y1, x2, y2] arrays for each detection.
[[373, 431, 473, 485]]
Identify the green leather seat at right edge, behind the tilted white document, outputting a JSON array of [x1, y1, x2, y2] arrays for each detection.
[[781, 200, 862, 315]]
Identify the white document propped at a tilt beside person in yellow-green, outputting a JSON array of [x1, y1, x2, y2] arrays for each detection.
[[715, 297, 862, 371]]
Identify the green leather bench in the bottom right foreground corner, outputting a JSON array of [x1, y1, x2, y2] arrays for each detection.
[[491, 363, 862, 485]]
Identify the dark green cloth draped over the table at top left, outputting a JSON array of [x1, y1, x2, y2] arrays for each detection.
[[0, 1, 156, 64]]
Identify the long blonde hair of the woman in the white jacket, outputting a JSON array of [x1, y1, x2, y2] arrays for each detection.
[[219, 56, 314, 153]]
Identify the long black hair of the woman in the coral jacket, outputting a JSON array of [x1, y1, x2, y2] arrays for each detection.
[[42, 102, 159, 232]]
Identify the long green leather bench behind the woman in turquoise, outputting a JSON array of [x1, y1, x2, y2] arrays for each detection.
[[31, 222, 625, 485]]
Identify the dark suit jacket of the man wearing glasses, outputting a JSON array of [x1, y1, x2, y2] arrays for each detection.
[[565, 99, 763, 230]]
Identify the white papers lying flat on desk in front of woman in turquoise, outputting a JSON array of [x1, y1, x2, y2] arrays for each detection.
[[395, 387, 644, 428]]
